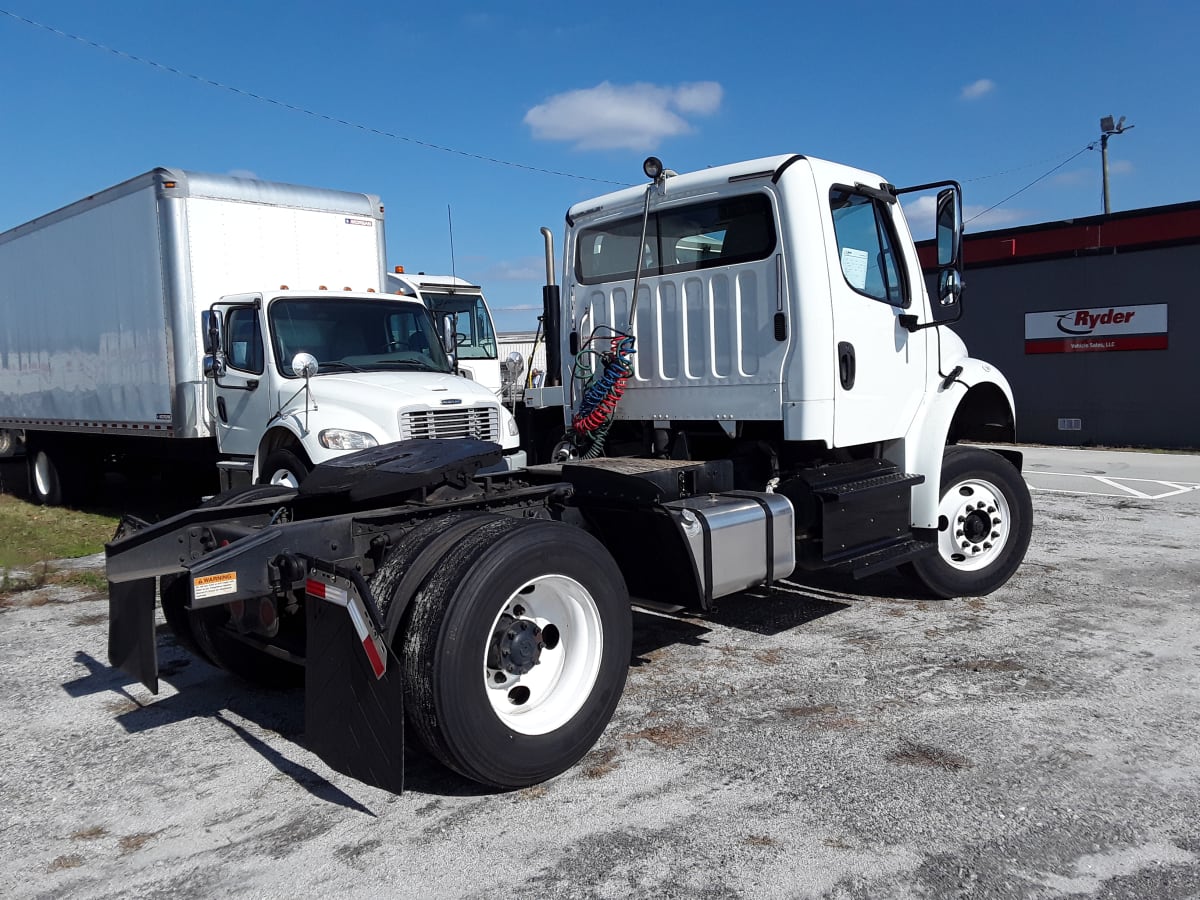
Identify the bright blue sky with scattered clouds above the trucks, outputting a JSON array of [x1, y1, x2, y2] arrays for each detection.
[[0, 0, 1200, 331]]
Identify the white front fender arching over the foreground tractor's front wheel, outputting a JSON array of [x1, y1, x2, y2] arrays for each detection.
[[884, 356, 1016, 528]]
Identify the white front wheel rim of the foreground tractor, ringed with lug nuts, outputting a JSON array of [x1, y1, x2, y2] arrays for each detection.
[[937, 479, 1013, 572]]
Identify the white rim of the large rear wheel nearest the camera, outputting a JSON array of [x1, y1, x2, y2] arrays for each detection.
[[482, 575, 604, 734]]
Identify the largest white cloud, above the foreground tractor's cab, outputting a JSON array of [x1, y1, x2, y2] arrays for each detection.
[[524, 82, 724, 150]]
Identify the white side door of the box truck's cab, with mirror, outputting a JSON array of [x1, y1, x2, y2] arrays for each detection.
[[212, 295, 275, 456]]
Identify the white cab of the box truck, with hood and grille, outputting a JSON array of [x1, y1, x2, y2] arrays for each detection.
[[204, 290, 524, 487]]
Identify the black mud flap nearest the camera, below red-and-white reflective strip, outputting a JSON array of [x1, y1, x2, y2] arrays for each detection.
[[305, 578, 404, 793]]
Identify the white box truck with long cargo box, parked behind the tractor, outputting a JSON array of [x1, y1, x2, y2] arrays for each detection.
[[0, 168, 523, 504]]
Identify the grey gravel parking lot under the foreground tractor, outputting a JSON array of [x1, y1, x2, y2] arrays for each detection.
[[0, 450, 1200, 900]]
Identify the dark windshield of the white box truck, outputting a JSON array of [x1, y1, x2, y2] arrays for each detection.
[[269, 296, 451, 377]]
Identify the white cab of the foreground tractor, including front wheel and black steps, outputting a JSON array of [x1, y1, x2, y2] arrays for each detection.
[[540, 155, 1030, 602]]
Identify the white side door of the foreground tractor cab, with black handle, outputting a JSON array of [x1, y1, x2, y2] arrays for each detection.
[[829, 185, 928, 446]]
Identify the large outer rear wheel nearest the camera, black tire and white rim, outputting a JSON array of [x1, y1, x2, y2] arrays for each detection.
[[397, 516, 632, 788]]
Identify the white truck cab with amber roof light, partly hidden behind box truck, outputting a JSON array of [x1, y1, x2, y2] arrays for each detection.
[[384, 265, 502, 396]]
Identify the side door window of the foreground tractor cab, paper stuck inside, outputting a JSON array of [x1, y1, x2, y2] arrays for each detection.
[[829, 186, 908, 306]]
